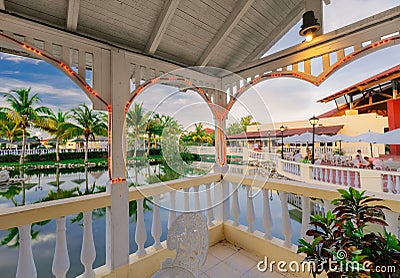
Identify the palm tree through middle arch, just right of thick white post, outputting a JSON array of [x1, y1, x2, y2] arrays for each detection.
[[126, 103, 150, 157]]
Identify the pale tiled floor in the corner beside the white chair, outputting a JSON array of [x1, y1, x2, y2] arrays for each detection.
[[200, 241, 294, 278]]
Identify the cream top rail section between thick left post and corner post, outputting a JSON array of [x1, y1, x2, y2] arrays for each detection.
[[129, 174, 222, 201]]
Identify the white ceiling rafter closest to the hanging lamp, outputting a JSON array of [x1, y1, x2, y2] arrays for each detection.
[[243, 2, 304, 63]]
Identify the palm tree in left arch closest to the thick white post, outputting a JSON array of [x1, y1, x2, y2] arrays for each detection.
[[67, 104, 108, 163]]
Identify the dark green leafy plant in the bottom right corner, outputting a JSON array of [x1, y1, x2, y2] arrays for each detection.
[[297, 187, 400, 277]]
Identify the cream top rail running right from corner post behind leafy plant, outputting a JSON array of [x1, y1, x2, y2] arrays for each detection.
[[224, 174, 400, 213]]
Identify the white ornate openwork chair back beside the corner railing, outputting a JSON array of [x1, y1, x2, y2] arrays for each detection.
[[152, 212, 208, 278]]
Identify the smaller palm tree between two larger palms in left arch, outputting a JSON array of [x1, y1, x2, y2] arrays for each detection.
[[47, 110, 75, 162]]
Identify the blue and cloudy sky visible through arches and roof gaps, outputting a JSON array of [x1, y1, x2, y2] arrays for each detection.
[[0, 0, 400, 135]]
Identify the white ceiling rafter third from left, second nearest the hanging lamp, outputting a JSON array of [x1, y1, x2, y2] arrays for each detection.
[[196, 0, 254, 66]]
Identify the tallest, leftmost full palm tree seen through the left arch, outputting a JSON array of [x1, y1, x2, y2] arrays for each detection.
[[1, 88, 51, 164]]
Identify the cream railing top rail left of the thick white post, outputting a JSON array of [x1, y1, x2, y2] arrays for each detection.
[[0, 193, 111, 230]]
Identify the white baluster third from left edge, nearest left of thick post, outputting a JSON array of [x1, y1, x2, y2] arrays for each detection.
[[81, 211, 96, 278]]
